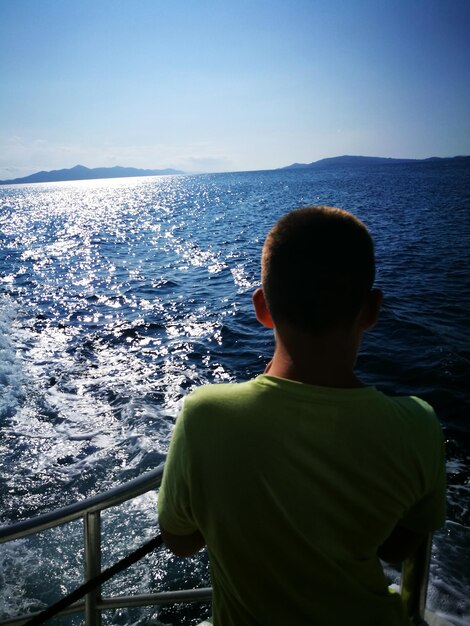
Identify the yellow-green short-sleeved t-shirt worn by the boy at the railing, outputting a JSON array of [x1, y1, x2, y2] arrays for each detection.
[[158, 375, 445, 626]]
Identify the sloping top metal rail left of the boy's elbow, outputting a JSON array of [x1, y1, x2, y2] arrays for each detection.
[[0, 463, 163, 543]]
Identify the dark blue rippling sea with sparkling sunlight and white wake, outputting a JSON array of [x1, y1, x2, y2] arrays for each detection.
[[0, 159, 470, 626]]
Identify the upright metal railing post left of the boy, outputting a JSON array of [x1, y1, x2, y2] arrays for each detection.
[[83, 511, 101, 626]]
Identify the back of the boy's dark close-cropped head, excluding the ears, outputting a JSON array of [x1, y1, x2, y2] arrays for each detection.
[[261, 206, 375, 335]]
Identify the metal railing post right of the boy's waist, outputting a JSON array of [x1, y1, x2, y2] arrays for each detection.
[[400, 534, 432, 626]]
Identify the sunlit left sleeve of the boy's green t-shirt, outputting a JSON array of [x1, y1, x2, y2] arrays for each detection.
[[157, 408, 197, 535]]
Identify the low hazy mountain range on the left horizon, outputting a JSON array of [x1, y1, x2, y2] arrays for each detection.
[[0, 165, 184, 185]]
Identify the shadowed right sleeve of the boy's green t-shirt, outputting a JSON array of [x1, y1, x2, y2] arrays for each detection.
[[399, 412, 446, 533]]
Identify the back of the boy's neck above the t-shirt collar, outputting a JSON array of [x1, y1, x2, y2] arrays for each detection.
[[265, 330, 364, 389]]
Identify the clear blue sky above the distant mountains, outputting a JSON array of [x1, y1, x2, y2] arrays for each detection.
[[0, 0, 470, 179]]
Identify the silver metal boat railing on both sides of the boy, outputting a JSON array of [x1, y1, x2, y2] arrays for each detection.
[[0, 464, 432, 626]]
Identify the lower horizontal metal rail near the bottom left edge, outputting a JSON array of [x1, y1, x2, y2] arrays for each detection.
[[0, 587, 212, 626]]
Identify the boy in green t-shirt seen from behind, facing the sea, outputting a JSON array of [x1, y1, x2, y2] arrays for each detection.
[[159, 207, 445, 626]]
